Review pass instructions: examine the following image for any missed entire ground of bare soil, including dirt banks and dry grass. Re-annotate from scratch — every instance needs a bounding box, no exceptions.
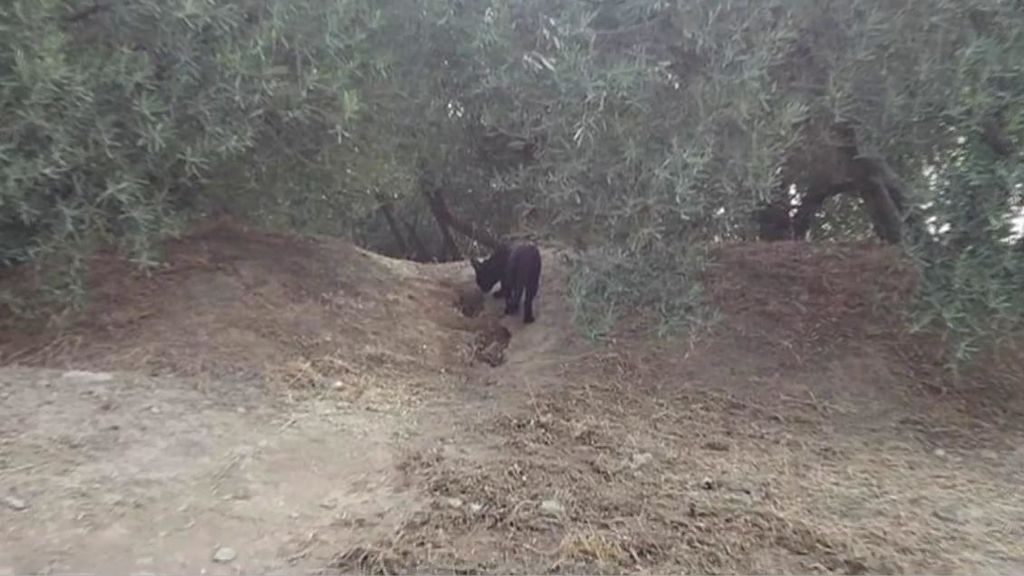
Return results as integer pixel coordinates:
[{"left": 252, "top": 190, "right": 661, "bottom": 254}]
[{"left": 0, "top": 224, "right": 1024, "bottom": 575}]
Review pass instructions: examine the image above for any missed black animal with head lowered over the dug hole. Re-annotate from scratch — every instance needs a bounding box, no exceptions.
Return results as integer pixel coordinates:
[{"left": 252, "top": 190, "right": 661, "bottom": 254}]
[{"left": 469, "top": 244, "right": 541, "bottom": 324}]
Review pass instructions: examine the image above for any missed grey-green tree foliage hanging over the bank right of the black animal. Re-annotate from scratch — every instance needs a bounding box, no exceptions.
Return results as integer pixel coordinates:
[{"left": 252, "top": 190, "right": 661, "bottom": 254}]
[{"left": 473, "top": 0, "right": 1024, "bottom": 359}]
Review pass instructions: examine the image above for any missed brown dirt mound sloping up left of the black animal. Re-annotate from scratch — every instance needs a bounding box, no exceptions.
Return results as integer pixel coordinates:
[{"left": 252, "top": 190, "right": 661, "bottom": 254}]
[{"left": 0, "top": 223, "right": 466, "bottom": 387}]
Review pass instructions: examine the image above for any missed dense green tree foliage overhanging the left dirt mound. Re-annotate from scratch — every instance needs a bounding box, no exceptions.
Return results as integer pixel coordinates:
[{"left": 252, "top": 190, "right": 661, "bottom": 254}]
[{"left": 0, "top": 0, "right": 380, "bottom": 302}]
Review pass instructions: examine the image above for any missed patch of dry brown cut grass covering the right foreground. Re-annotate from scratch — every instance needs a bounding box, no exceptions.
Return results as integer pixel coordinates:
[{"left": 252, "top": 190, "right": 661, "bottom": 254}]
[{"left": 382, "top": 344, "right": 1024, "bottom": 574}]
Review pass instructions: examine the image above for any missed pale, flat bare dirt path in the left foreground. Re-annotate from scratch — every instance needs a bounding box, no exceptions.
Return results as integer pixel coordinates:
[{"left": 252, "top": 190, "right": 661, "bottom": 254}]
[{"left": 0, "top": 369, "right": 418, "bottom": 574}]
